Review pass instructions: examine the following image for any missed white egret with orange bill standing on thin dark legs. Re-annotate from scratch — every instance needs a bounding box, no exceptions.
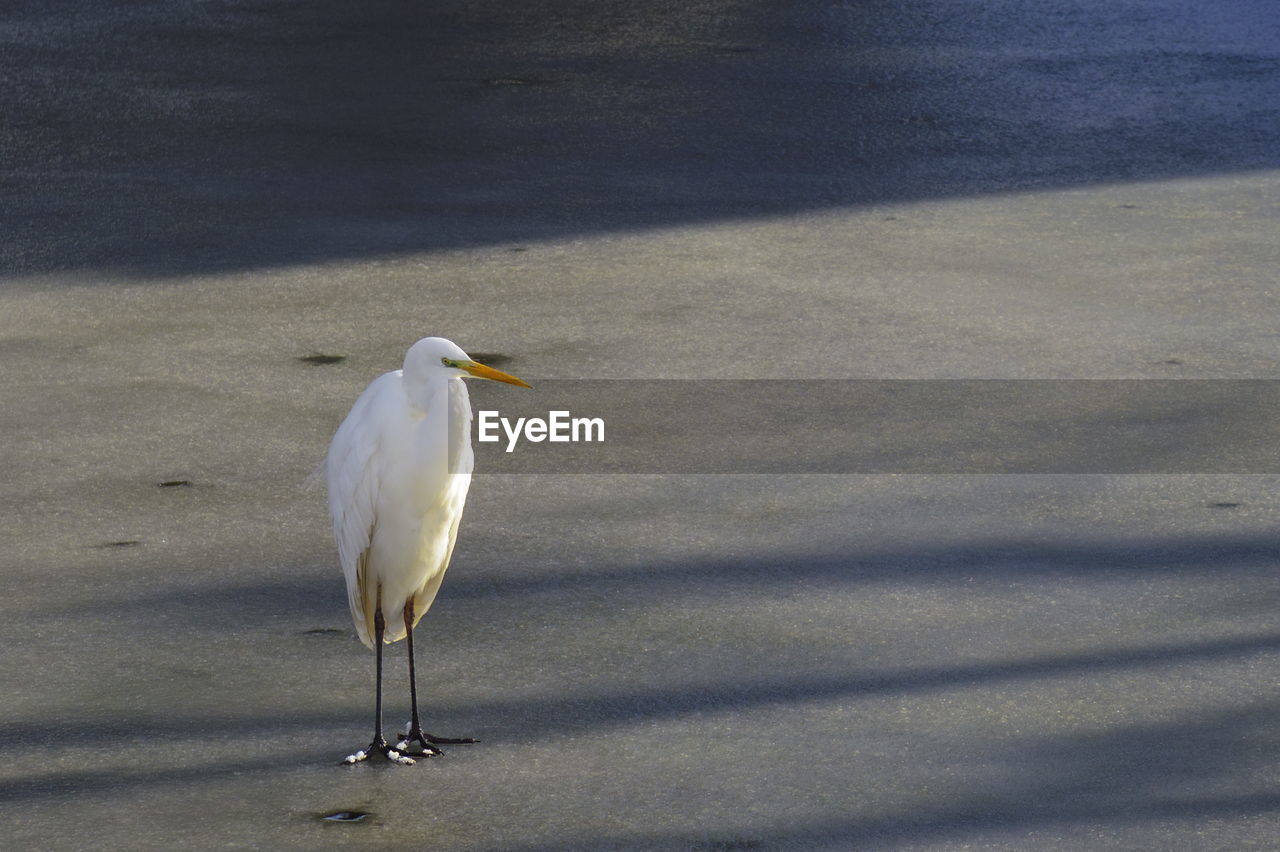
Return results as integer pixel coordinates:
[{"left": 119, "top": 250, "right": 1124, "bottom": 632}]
[{"left": 325, "top": 338, "right": 529, "bottom": 764}]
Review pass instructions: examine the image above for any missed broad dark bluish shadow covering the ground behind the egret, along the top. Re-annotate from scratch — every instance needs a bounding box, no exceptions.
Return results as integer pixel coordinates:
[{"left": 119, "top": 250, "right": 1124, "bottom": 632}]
[{"left": 0, "top": 0, "right": 1280, "bottom": 278}]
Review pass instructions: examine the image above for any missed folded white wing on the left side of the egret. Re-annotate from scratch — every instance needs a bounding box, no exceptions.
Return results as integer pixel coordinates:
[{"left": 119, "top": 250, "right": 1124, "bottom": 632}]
[{"left": 325, "top": 371, "right": 406, "bottom": 647}]
